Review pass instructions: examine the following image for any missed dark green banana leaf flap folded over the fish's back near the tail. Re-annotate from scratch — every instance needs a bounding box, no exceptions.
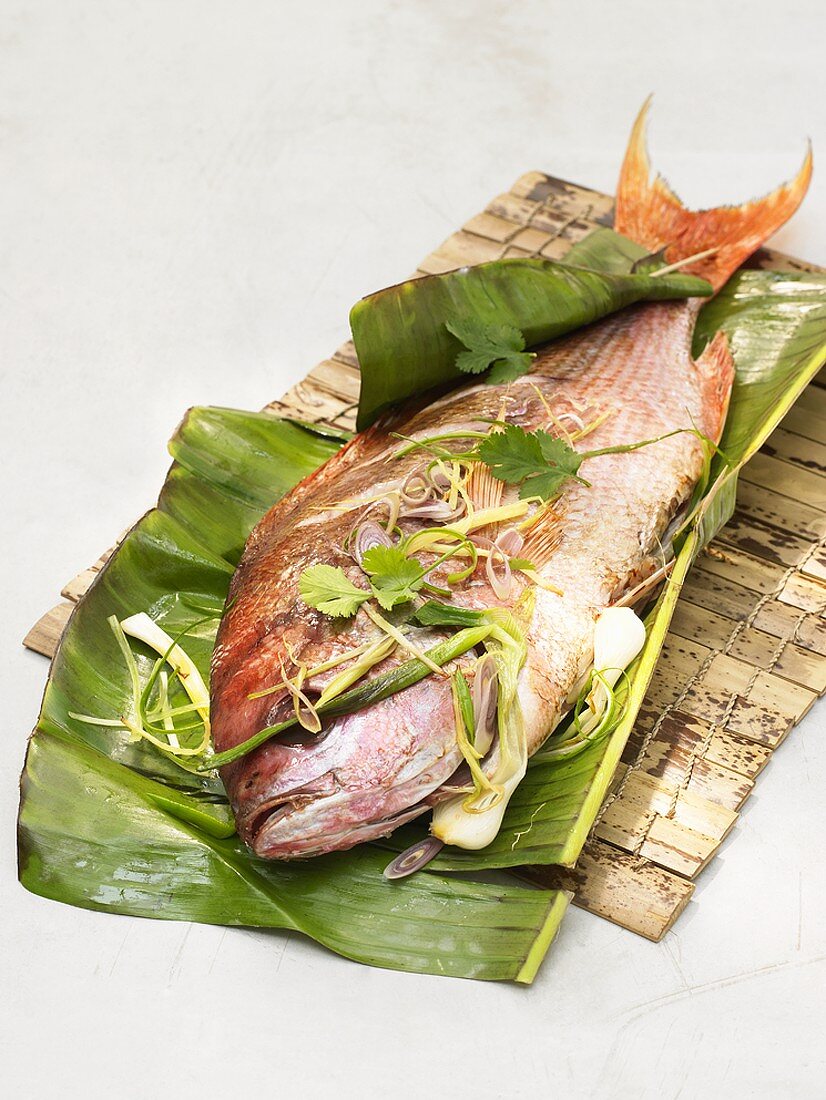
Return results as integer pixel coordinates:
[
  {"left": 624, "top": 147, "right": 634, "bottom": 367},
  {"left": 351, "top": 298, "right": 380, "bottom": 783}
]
[{"left": 350, "top": 229, "right": 712, "bottom": 430}]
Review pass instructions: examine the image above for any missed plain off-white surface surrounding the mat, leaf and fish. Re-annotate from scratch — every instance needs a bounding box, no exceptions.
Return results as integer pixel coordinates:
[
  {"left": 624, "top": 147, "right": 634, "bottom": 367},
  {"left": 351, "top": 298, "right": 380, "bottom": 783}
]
[{"left": 0, "top": 0, "right": 826, "bottom": 1100}]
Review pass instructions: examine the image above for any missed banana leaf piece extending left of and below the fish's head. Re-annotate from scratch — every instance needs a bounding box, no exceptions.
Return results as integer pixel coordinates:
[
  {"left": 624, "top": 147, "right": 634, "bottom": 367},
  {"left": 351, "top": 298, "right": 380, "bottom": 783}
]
[{"left": 19, "top": 409, "right": 569, "bottom": 982}]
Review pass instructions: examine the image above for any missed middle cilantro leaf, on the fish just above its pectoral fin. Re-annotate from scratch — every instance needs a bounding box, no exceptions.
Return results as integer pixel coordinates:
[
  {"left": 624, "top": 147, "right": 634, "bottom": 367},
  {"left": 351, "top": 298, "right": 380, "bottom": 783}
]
[{"left": 478, "top": 424, "right": 582, "bottom": 501}]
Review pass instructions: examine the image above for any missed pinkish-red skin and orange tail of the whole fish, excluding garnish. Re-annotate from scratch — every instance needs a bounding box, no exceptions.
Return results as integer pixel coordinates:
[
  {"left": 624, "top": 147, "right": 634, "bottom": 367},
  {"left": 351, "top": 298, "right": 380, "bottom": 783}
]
[{"left": 211, "top": 109, "right": 811, "bottom": 859}]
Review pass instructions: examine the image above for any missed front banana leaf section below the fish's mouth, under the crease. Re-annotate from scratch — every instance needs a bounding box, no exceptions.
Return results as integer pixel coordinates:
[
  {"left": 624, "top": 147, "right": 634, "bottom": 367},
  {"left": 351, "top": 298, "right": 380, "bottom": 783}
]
[{"left": 20, "top": 733, "right": 566, "bottom": 981}]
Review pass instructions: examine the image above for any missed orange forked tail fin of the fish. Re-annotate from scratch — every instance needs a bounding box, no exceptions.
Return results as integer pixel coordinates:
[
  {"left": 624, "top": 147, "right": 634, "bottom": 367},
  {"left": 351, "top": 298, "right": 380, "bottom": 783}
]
[{"left": 615, "top": 99, "right": 812, "bottom": 290}]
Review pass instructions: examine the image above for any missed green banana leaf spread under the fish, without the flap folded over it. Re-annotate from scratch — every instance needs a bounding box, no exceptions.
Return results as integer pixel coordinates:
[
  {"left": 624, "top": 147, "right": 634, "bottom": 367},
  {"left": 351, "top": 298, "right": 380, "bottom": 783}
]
[{"left": 20, "top": 249, "right": 826, "bottom": 981}]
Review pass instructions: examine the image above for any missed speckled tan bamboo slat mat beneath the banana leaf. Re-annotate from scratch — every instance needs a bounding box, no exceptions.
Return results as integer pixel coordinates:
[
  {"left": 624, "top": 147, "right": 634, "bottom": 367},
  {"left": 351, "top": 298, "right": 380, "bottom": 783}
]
[{"left": 24, "top": 172, "right": 826, "bottom": 939}]
